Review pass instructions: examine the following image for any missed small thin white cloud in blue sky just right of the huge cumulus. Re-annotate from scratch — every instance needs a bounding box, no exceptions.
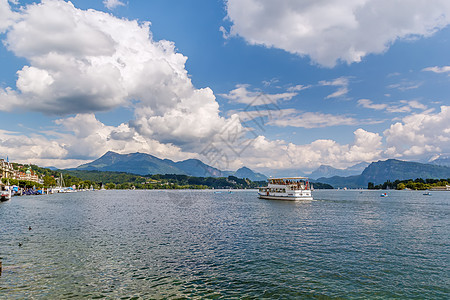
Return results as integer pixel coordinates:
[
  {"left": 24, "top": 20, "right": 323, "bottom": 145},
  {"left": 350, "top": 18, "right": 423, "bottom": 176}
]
[{"left": 220, "top": 84, "right": 297, "bottom": 106}]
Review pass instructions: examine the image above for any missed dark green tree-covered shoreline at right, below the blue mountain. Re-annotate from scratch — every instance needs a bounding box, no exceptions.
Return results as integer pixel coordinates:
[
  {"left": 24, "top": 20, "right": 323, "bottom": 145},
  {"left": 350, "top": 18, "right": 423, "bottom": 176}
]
[{"left": 367, "top": 178, "right": 450, "bottom": 190}]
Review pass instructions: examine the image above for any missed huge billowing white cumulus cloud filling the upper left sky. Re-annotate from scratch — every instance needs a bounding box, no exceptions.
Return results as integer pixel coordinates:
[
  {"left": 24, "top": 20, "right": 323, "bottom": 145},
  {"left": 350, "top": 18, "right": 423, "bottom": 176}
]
[{"left": 0, "top": 0, "right": 236, "bottom": 147}]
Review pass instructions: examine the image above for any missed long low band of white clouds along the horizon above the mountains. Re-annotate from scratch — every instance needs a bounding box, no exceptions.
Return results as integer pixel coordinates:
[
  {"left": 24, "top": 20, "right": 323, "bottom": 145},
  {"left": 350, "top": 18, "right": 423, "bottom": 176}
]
[{"left": 0, "top": 106, "right": 450, "bottom": 172}]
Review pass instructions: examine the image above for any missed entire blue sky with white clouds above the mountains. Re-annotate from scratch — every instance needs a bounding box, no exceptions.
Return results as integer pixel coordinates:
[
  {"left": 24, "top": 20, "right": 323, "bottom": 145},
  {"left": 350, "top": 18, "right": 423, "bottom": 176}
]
[{"left": 0, "top": 0, "right": 450, "bottom": 175}]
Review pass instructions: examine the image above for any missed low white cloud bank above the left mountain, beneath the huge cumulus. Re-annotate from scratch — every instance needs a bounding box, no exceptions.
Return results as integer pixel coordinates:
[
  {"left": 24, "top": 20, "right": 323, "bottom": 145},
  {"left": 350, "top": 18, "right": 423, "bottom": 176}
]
[{"left": 0, "top": 114, "right": 196, "bottom": 168}]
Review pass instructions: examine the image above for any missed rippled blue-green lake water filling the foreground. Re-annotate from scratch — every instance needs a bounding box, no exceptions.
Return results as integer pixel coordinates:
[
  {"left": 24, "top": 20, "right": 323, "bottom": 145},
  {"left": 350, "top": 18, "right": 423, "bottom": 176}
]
[{"left": 0, "top": 190, "right": 450, "bottom": 299}]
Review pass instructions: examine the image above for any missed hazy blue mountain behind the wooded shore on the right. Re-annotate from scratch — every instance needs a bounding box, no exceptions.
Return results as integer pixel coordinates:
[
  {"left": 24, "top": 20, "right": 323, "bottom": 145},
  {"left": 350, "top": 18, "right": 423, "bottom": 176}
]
[{"left": 317, "top": 159, "right": 450, "bottom": 188}]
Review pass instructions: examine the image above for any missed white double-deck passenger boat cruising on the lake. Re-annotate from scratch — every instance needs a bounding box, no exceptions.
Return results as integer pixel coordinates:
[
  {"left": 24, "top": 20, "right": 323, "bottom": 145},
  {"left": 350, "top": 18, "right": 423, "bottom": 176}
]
[{"left": 258, "top": 177, "right": 313, "bottom": 200}]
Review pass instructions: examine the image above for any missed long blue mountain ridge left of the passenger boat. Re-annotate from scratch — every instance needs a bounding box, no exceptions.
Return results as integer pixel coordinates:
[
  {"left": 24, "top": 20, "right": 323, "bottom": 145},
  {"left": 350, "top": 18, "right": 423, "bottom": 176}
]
[{"left": 73, "top": 151, "right": 267, "bottom": 181}]
